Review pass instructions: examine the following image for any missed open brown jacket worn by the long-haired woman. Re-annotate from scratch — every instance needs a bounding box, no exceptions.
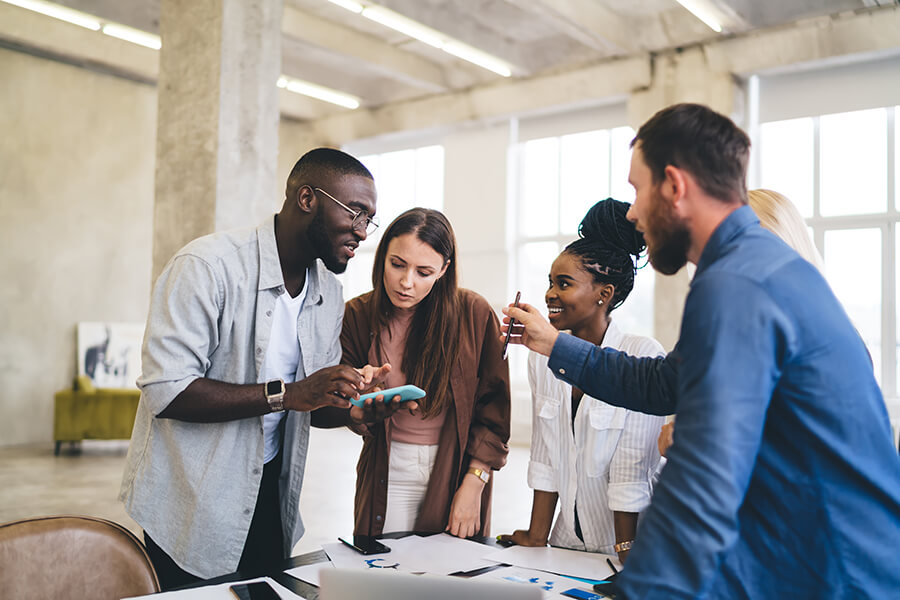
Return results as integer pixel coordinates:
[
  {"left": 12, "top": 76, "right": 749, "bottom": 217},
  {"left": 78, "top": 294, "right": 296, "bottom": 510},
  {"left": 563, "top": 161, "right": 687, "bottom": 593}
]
[{"left": 341, "top": 289, "right": 510, "bottom": 535}]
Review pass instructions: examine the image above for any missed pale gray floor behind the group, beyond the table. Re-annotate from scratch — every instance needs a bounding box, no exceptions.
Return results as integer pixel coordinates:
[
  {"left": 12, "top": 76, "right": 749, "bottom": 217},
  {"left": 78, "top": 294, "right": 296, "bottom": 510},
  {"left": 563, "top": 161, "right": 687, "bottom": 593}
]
[{"left": 0, "top": 429, "right": 531, "bottom": 554}]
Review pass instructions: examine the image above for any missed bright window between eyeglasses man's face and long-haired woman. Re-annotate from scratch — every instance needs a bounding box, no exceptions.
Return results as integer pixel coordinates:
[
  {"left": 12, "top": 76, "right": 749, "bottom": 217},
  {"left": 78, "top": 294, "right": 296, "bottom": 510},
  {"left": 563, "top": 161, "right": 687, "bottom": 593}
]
[{"left": 342, "top": 146, "right": 444, "bottom": 300}]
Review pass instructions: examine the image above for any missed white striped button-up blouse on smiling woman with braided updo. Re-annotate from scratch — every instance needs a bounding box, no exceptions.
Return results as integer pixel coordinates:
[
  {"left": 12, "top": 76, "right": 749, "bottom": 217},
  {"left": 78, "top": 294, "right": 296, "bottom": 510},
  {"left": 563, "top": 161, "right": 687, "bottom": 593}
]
[{"left": 528, "top": 322, "right": 665, "bottom": 554}]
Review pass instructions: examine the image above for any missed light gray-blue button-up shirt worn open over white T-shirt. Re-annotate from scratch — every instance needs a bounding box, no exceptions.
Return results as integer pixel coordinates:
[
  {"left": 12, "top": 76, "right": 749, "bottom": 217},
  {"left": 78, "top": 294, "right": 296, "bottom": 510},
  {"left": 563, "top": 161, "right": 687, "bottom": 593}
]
[{"left": 120, "top": 217, "right": 344, "bottom": 578}]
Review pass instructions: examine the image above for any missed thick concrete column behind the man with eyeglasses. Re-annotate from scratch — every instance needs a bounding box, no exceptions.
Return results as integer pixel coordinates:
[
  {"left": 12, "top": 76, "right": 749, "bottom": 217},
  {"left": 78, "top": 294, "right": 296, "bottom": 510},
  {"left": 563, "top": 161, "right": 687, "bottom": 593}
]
[{"left": 152, "top": 0, "right": 283, "bottom": 280}]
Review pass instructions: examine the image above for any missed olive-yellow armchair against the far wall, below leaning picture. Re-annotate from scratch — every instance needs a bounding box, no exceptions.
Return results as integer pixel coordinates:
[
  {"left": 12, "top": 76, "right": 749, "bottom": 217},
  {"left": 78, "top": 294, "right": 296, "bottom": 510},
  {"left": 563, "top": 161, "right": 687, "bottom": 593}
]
[{"left": 53, "top": 375, "right": 141, "bottom": 455}]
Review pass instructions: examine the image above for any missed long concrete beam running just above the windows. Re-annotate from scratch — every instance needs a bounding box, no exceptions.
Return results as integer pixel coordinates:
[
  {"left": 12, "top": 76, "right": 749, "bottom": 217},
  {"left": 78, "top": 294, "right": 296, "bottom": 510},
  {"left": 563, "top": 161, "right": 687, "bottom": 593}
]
[{"left": 306, "top": 7, "right": 900, "bottom": 144}]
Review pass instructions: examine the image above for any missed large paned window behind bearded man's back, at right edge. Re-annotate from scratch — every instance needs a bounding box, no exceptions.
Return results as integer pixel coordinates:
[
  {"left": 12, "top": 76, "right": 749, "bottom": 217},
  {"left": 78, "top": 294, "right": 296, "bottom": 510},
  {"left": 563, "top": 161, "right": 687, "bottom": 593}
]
[{"left": 759, "top": 106, "right": 900, "bottom": 396}]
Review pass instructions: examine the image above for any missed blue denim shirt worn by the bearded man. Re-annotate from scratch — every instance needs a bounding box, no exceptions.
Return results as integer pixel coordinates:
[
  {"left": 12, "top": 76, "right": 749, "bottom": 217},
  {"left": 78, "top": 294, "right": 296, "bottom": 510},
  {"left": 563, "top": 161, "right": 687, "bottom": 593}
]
[{"left": 548, "top": 207, "right": 900, "bottom": 599}]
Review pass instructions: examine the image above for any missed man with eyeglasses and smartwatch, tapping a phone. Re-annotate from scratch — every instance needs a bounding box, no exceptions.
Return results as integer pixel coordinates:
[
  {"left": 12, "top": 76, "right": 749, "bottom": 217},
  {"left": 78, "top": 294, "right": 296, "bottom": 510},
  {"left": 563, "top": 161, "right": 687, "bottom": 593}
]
[{"left": 120, "top": 148, "right": 384, "bottom": 589}]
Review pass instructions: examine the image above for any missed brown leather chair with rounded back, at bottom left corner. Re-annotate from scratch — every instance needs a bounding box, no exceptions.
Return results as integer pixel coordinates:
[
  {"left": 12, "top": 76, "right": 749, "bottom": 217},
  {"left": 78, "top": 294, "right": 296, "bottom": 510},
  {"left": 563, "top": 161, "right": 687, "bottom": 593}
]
[{"left": 0, "top": 516, "right": 159, "bottom": 600}]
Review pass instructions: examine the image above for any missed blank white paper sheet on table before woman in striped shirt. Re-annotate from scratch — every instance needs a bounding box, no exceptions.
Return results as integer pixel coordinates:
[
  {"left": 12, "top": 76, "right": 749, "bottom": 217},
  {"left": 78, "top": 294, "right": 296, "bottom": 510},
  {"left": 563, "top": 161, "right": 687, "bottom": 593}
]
[{"left": 482, "top": 546, "right": 620, "bottom": 579}]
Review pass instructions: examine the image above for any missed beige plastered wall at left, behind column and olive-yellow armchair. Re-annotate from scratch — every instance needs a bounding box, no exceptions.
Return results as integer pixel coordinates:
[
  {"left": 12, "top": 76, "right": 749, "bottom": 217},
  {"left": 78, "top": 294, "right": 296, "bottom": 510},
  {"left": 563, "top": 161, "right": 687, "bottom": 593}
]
[{"left": 0, "top": 49, "right": 334, "bottom": 445}]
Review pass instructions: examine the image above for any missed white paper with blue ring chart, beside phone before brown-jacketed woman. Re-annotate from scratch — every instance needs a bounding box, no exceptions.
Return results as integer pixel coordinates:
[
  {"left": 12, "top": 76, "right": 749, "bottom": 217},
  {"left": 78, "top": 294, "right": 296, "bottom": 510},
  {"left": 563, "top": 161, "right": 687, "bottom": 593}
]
[{"left": 322, "top": 533, "right": 495, "bottom": 575}]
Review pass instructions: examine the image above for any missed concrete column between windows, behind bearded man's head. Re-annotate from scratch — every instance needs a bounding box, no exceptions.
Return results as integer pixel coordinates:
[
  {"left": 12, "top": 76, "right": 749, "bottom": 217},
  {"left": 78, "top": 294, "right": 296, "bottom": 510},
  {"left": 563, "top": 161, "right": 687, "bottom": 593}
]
[{"left": 628, "top": 47, "right": 744, "bottom": 350}]
